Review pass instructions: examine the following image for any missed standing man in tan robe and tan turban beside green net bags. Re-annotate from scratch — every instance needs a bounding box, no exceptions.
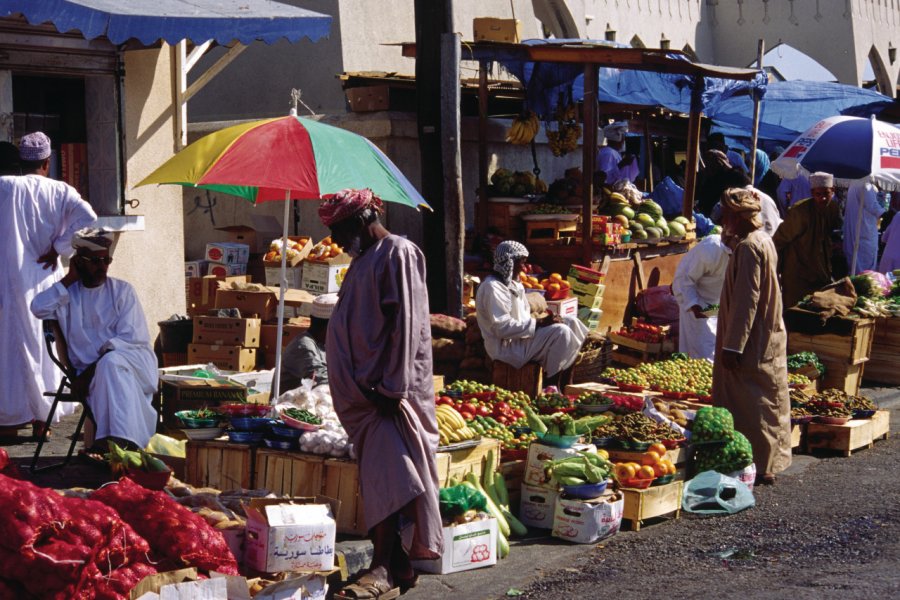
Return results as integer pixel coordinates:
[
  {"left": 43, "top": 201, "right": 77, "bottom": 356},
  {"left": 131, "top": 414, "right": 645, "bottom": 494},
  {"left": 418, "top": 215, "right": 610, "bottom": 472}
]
[{"left": 712, "top": 188, "right": 791, "bottom": 483}]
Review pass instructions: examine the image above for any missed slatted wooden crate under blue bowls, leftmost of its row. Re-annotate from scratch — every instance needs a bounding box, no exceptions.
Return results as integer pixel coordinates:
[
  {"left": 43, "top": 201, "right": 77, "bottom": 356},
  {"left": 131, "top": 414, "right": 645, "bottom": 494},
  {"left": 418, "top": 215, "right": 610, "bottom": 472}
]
[{"left": 184, "top": 441, "right": 256, "bottom": 490}]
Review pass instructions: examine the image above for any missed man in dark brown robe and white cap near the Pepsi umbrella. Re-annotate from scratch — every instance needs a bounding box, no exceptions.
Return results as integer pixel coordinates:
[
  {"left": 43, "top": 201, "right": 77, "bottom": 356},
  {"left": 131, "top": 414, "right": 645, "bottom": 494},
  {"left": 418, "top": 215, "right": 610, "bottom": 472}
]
[{"left": 772, "top": 173, "right": 842, "bottom": 308}]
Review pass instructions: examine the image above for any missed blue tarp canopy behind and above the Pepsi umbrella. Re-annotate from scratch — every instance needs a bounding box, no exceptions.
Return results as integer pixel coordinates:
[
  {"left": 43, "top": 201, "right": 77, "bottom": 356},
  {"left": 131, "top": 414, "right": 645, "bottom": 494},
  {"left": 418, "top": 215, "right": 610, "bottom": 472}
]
[{"left": 706, "top": 81, "right": 893, "bottom": 142}]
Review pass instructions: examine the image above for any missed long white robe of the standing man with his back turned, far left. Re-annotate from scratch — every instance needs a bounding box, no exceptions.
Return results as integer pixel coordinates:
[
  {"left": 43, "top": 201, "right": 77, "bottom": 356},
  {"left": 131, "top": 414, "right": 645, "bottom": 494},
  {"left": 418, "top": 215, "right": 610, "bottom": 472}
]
[{"left": 0, "top": 175, "right": 97, "bottom": 426}]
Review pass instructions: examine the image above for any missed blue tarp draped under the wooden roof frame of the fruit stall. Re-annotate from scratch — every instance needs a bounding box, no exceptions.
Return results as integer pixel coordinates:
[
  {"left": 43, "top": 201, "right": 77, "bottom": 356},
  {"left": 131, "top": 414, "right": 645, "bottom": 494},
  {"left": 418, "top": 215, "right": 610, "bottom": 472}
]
[{"left": 499, "top": 40, "right": 766, "bottom": 118}]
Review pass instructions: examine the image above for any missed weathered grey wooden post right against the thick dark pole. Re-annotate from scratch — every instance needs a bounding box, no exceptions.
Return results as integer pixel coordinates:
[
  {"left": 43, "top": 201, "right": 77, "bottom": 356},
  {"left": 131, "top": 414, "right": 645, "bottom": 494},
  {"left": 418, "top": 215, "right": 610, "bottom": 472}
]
[{"left": 441, "top": 33, "right": 465, "bottom": 317}]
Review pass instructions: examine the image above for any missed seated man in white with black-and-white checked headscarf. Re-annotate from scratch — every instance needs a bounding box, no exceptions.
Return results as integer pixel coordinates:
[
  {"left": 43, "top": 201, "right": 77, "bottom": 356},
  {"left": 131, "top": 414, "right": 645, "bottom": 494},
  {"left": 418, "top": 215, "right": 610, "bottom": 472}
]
[{"left": 475, "top": 240, "right": 588, "bottom": 389}]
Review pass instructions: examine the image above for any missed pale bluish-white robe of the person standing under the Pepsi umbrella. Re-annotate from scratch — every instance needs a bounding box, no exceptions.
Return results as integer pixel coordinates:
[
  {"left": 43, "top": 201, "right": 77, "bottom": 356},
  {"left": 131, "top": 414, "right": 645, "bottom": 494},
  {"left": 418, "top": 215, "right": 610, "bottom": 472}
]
[{"left": 844, "top": 181, "right": 887, "bottom": 275}]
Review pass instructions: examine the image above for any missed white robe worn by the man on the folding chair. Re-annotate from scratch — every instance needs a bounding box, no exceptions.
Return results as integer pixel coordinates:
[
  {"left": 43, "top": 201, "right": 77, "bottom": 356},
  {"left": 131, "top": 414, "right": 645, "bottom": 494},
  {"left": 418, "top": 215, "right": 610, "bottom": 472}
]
[{"left": 31, "top": 277, "right": 158, "bottom": 448}]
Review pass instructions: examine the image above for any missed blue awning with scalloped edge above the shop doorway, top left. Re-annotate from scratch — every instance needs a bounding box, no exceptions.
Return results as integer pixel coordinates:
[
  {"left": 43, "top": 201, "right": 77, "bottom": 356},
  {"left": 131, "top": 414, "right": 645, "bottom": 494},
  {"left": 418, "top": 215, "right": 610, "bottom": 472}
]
[{"left": 0, "top": 0, "right": 331, "bottom": 45}]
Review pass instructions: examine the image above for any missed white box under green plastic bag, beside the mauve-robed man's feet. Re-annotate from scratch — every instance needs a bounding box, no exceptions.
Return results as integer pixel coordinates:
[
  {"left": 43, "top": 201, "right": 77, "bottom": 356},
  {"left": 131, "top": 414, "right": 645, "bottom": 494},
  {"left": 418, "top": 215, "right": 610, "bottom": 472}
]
[{"left": 413, "top": 517, "right": 497, "bottom": 575}]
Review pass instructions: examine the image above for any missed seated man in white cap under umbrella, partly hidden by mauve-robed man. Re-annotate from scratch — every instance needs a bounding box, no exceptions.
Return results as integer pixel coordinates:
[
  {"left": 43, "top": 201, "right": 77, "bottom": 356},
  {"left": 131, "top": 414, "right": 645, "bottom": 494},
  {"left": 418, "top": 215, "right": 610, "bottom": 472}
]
[{"left": 281, "top": 294, "right": 337, "bottom": 391}]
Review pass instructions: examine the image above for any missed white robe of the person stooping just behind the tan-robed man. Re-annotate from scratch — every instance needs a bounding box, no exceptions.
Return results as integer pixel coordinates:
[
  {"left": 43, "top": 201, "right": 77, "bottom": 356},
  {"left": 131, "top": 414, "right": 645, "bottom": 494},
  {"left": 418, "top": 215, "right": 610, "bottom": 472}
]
[{"left": 672, "top": 235, "right": 731, "bottom": 362}]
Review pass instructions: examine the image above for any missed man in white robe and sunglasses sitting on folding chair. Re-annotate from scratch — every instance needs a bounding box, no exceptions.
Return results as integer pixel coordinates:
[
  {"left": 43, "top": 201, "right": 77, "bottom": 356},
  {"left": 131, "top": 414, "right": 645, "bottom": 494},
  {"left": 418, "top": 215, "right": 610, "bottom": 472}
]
[{"left": 31, "top": 229, "right": 157, "bottom": 458}]
